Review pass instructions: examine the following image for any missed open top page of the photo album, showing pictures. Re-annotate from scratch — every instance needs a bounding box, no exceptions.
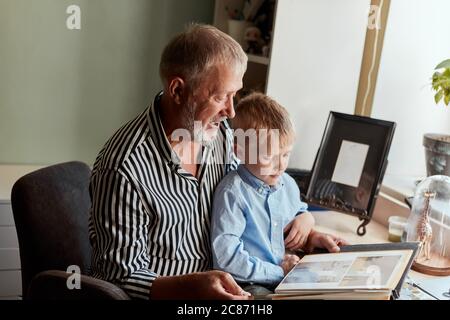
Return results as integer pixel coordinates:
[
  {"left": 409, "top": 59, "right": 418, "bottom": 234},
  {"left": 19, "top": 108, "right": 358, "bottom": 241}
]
[{"left": 275, "top": 250, "right": 413, "bottom": 293}]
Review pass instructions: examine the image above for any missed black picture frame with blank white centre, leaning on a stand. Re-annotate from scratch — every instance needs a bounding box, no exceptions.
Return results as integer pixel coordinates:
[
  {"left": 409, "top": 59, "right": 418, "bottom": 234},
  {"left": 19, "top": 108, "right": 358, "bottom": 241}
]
[{"left": 306, "top": 111, "right": 396, "bottom": 236}]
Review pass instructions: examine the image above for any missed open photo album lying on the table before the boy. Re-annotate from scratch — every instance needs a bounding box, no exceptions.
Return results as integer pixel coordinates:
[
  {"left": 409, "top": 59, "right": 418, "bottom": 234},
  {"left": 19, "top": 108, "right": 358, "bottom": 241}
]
[{"left": 272, "top": 242, "right": 418, "bottom": 300}]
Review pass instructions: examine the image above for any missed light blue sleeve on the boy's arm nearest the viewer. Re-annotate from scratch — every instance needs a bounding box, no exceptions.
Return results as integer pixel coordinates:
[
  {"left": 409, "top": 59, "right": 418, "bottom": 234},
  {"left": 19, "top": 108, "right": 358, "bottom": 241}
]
[{"left": 211, "top": 185, "right": 284, "bottom": 284}]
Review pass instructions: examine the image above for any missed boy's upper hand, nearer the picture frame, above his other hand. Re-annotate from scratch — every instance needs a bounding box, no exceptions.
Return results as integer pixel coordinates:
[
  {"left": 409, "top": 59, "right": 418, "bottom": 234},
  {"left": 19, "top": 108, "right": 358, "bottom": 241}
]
[{"left": 284, "top": 212, "right": 315, "bottom": 251}]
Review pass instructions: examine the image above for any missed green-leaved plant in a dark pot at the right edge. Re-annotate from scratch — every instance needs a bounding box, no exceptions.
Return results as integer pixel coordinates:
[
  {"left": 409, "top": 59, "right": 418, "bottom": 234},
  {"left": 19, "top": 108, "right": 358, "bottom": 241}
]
[{"left": 423, "top": 59, "right": 450, "bottom": 176}]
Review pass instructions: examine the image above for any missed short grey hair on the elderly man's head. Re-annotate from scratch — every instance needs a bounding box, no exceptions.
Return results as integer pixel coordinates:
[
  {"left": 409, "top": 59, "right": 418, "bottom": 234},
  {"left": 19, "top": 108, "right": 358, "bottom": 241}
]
[{"left": 159, "top": 24, "right": 247, "bottom": 88}]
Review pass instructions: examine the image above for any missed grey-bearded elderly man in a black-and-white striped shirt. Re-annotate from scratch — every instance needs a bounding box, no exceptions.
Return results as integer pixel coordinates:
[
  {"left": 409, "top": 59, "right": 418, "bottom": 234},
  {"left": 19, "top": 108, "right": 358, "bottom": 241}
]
[{"left": 89, "top": 25, "right": 348, "bottom": 299}]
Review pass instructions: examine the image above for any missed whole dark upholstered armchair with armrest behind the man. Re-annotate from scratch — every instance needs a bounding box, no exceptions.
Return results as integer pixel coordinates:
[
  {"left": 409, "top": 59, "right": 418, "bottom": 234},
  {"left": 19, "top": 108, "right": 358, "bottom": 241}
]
[{"left": 11, "top": 162, "right": 129, "bottom": 299}]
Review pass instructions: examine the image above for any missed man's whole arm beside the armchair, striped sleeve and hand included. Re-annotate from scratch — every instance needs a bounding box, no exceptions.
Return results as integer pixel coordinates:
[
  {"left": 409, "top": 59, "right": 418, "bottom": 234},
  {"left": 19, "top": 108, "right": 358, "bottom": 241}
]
[{"left": 91, "top": 170, "right": 249, "bottom": 299}]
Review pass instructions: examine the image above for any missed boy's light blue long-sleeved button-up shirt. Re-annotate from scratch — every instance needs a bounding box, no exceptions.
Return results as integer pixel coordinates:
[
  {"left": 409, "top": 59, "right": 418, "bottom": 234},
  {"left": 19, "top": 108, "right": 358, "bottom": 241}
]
[{"left": 211, "top": 165, "right": 308, "bottom": 284}]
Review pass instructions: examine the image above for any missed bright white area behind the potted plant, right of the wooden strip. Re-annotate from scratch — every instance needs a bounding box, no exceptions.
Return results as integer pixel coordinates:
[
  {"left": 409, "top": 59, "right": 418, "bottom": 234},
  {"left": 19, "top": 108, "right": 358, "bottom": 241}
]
[{"left": 372, "top": 0, "right": 450, "bottom": 176}]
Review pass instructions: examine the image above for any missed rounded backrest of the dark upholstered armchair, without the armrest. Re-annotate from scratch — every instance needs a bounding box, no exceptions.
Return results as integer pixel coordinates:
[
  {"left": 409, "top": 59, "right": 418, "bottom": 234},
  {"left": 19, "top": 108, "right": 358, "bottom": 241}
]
[{"left": 11, "top": 162, "right": 91, "bottom": 298}]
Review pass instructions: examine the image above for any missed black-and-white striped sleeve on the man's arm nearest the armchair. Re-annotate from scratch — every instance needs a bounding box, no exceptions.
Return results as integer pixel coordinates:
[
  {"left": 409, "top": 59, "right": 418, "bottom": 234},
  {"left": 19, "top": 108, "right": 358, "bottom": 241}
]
[{"left": 90, "top": 169, "right": 157, "bottom": 299}]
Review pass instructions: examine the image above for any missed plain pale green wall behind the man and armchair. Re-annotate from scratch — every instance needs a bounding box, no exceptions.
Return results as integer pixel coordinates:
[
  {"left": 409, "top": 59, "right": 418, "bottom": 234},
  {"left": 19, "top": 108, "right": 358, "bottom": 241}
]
[{"left": 0, "top": 0, "right": 214, "bottom": 164}]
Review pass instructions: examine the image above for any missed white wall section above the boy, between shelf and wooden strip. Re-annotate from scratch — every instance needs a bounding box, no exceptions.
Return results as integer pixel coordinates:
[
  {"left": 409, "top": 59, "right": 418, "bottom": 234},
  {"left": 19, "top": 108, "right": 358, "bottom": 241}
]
[{"left": 267, "top": 0, "right": 370, "bottom": 169}]
